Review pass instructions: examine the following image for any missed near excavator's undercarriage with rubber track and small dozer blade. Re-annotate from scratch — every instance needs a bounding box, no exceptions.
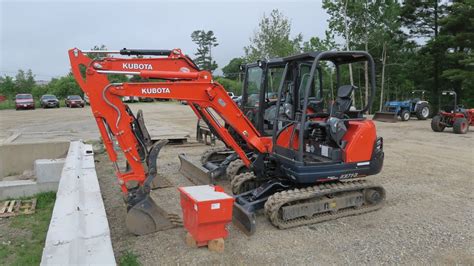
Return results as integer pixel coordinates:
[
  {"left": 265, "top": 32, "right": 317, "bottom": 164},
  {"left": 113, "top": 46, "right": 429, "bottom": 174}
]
[{"left": 234, "top": 174, "right": 385, "bottom": 235}]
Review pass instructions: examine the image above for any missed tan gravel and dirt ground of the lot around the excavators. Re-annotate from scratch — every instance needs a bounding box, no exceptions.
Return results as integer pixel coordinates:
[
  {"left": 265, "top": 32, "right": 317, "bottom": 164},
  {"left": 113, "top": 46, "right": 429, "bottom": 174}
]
[{"left": 0, "top": 103, "right": 474, "bottom": 265}]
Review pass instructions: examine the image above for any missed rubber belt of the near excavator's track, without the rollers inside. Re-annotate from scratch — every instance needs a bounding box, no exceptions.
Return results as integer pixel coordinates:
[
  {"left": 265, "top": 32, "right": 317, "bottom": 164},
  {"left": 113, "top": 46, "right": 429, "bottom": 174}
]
[{"left": 265, "top": 180, "right": 385, "bottom": 229}]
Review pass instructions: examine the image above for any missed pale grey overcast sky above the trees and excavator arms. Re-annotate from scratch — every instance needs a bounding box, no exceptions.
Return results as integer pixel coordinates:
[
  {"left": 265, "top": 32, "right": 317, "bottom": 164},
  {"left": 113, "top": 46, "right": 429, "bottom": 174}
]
[{"left": 0, "top": 0, "right": 328, "bottom": 80}]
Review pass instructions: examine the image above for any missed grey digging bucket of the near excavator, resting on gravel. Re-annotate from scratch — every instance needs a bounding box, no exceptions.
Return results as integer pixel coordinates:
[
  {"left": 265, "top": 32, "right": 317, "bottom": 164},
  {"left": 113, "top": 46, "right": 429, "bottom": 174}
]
[{"left": 125, "top": 195, "right": 182, "bottom": 235}]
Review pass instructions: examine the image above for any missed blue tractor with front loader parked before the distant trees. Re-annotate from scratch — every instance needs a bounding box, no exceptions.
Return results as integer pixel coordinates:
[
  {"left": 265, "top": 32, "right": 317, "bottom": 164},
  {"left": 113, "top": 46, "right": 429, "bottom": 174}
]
[{"left": 372, "top": 90, "right": 431, "bottom": 122}]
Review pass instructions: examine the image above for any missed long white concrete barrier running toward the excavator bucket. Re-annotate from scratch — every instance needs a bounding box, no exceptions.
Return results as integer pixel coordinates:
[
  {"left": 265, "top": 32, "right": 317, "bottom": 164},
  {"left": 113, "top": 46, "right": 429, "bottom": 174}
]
[{"left": 41, "top": 141, "right": 116, "bottom": 265}]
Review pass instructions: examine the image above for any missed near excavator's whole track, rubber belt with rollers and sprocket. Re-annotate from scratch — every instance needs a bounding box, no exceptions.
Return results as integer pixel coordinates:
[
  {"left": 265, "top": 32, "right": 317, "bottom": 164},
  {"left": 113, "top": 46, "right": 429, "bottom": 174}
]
[{"left": 265, "top": 180, "right": 385, "bottom": 229}]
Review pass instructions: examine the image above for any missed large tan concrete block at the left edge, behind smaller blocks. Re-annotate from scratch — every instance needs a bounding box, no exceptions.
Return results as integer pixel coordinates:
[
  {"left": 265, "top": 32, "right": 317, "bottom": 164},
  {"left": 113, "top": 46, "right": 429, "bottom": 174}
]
[{"left": 0, "top": 141, "right": 69, "bottom": 177}]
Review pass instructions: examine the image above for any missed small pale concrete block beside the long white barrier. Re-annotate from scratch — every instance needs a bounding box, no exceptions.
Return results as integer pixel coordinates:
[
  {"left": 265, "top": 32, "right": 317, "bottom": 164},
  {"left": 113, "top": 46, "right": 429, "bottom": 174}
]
[{"left": 34, "top": 159, "right": 66, "bottom": 183}]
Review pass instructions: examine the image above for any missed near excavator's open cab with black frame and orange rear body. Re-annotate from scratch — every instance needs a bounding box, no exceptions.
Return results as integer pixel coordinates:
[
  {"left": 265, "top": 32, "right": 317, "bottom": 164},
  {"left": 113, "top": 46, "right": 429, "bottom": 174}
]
[{"left": 266, "top": 51, "right": 381, "bottom": 183}]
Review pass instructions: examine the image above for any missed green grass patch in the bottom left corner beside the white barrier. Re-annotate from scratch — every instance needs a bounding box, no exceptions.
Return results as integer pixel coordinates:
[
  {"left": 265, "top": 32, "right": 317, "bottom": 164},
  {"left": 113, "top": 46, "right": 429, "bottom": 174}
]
[{"left": 0, "top": 192, "right": 56, "bottom": 265}]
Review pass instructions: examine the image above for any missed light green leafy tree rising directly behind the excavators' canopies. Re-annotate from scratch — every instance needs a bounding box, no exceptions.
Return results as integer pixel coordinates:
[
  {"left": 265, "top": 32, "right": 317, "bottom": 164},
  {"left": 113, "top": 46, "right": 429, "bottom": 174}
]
[{"left": 244, "top": 9, "right": 303, "bottom": 62}]
